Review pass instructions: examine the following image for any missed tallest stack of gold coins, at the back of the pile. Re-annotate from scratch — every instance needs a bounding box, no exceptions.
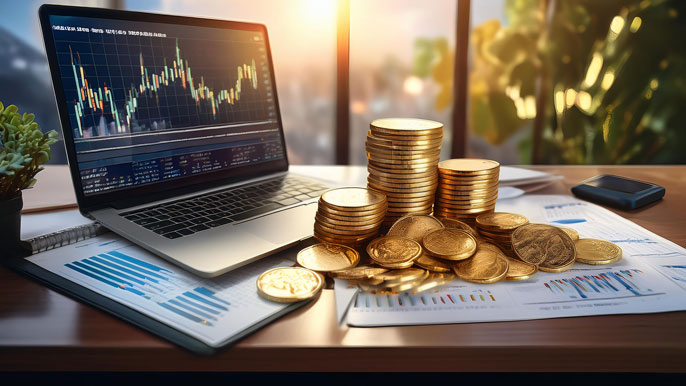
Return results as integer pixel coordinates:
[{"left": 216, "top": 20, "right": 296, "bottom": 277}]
[{"left": 366, "top": 118, "right": 443, "bottom": 229}]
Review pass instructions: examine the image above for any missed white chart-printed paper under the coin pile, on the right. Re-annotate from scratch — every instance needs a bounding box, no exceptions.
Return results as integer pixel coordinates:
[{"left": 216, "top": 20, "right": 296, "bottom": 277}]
[{"left": 344, "top": 195, "right": 686, "bottom": 326}]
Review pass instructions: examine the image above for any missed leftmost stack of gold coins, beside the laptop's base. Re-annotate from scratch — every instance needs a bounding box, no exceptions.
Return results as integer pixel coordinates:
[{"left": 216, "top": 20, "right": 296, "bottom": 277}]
[{"left": 314, "top": 187, "right": 388, "bottom": 248}]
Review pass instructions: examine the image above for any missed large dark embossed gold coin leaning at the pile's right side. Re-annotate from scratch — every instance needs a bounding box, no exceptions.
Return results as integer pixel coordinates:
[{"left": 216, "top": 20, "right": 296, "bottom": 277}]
[{"left": 512, "top": 224, "right": 576, "bottom": 269}]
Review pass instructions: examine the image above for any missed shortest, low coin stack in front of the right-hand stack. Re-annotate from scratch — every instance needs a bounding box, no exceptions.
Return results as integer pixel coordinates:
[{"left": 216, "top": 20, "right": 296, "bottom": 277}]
[{"left": 476, "top": 212, "right": 529, "bottom": 256}]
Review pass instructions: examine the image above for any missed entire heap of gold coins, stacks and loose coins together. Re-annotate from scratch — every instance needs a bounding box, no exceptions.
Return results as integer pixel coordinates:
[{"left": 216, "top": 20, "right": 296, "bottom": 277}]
[{"left": 258, "top": 118, "right": 622, "bottom": 302}]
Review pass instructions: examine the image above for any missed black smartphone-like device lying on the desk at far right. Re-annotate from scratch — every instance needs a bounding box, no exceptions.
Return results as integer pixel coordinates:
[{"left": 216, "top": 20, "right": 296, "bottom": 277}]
[{"left": 572, "top": 174, "right": 665, "bottom": 209}]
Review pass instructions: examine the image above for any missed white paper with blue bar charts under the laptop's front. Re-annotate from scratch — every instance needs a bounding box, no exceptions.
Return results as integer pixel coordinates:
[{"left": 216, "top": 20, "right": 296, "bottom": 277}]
[{"left": 27, "top": 233, "right": 293, "bottom": 347}]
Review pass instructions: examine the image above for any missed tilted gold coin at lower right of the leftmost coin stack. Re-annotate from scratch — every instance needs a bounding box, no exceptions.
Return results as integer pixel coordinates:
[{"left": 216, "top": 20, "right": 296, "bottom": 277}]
[{"left": 367, "top": 236, "right": 422, "bottom": 268}]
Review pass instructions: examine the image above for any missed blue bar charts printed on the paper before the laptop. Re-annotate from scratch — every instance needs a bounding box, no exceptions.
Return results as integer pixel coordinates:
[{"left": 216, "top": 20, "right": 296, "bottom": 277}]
[{"left": 64, "top": 251, "right": 232, "bottom": 326}]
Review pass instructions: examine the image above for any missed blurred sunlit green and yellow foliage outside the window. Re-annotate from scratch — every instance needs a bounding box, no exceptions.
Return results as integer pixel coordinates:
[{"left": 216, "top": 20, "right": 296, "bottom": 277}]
[{"left": 414, "top": 0, "right": 686, "bottom": 164}]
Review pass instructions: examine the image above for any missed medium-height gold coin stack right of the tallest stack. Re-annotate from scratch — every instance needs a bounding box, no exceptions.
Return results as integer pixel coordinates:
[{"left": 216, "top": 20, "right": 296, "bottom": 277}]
[{"left": 434, "top": 158, "right": 500, "bottom": 226}]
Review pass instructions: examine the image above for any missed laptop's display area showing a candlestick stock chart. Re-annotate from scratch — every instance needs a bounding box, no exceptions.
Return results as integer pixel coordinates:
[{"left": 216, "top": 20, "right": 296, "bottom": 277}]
[{"left": 50, "top": 15, "right": 285, "bottom": 195}]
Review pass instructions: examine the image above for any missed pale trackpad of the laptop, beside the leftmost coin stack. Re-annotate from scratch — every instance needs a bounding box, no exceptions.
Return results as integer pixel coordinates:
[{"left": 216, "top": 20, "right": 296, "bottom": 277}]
[{"left": 241, "top": 202, "right": 317, "bottom": 245}]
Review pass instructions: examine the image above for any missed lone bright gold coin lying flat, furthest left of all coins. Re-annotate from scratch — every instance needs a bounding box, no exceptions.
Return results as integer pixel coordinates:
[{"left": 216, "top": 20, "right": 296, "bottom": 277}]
[{"left": 257, "top": 267, "right": 324, "bottom": 303}]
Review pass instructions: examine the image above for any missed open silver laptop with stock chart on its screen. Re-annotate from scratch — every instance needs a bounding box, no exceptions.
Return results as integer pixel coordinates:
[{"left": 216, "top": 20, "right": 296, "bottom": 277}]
[{"left": 39, "top": 5, "right": 327, "bottom": 277}]
